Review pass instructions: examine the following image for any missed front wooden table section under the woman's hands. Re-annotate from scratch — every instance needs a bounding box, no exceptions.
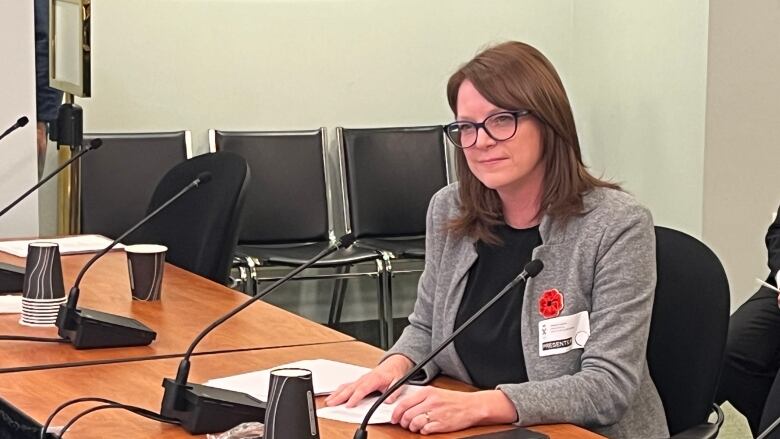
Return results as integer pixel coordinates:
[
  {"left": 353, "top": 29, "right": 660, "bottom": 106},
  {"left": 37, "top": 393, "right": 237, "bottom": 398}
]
[{"left": 0, "top": 342, "right": 601, "bottom": 439}]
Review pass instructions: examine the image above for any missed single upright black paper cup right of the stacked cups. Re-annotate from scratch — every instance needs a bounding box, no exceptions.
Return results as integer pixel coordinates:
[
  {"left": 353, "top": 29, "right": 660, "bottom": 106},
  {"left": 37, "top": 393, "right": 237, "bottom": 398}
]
[{"left": 125, "top": 244, "right": 168, "bottom": 301}]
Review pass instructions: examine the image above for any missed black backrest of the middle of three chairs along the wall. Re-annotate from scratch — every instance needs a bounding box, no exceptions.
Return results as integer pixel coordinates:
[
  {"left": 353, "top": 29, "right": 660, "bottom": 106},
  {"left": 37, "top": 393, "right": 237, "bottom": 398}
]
[{"left": 209, "top": 128, "right": 330, "bottom": 244}]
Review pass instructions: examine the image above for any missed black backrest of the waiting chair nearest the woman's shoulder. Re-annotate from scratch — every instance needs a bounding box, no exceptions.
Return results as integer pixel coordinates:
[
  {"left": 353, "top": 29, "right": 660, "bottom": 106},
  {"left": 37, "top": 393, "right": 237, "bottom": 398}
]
[{"left": 336, "top": 125, "right": 447, "bottom": 238}]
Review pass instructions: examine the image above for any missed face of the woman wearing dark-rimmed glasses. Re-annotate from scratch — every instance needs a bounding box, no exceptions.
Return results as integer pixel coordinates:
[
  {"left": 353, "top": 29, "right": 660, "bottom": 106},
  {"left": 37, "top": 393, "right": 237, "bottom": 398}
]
[{"left": 457, "top": 80, "right": 544, "bottom": 198}]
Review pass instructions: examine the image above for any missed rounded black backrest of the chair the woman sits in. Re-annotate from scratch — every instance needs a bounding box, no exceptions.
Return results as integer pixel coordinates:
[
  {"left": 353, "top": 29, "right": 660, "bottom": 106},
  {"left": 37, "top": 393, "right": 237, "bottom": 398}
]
[{"left": 647, "top": 226, "right": 729, "bottom": 435}]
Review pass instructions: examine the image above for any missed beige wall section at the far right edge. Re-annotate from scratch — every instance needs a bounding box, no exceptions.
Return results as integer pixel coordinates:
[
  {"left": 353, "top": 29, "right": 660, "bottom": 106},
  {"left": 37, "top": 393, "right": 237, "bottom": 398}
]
[{"left": 704, "top": 0, "right": 780, "bottom": 309}]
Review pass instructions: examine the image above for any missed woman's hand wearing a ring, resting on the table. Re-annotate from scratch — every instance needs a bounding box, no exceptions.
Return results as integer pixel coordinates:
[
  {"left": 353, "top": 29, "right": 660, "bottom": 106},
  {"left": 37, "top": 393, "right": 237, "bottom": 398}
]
[{"left": 391, "top": 387, "right": 517, "bottom": 434}]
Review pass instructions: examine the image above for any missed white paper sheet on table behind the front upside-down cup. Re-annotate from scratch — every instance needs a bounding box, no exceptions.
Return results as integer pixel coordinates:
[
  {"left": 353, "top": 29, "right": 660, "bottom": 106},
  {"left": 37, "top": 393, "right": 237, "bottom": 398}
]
[{"left": 205, "top": 359, "right": 371, "bottom": 401}]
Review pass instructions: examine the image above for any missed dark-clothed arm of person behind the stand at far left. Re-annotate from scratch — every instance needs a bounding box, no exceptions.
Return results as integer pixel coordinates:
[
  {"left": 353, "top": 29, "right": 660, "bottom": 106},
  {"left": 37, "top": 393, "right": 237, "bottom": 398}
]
[{"left": 35, "top": 0, "right": 62, "bottom": 175}]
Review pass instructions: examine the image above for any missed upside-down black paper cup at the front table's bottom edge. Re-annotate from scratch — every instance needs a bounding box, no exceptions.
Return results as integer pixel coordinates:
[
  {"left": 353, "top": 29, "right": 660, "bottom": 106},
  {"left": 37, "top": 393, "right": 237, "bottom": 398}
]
[{"left": 263, "top": 368, "right": 320, "bottom": 439}]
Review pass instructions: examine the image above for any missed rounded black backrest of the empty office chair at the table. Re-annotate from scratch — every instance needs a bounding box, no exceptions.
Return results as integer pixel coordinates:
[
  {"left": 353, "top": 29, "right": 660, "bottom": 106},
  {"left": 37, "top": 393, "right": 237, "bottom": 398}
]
[{"left": 125, "top": 152, "right": 250, "bottom": 283}]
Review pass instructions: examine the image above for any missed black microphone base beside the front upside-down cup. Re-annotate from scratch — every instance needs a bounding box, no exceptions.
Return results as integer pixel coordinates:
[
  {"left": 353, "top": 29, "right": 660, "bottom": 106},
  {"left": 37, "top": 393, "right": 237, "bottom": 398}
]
[{"left": 160, "top": 378, "right": 266, "bottom": 434}]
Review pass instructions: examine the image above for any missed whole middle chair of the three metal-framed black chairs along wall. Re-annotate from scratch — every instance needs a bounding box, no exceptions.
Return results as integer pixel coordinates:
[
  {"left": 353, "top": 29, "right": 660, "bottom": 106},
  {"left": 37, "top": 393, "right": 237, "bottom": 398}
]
[{"left": 209, "top": 128, "right": 384, "bottom": 334}]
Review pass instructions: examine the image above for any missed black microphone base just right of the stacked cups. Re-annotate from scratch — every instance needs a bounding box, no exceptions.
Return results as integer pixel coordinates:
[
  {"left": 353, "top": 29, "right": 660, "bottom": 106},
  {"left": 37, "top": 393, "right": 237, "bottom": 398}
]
[{"left": 56, "top": 305, "right": 157, "bottom": 349}]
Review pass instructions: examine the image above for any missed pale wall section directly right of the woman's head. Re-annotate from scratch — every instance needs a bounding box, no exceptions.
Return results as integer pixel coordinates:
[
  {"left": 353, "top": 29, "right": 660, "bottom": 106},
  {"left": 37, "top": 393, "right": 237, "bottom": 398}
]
[{"left": 567, "top": 0, "right": 708, "bottom": 237}]
